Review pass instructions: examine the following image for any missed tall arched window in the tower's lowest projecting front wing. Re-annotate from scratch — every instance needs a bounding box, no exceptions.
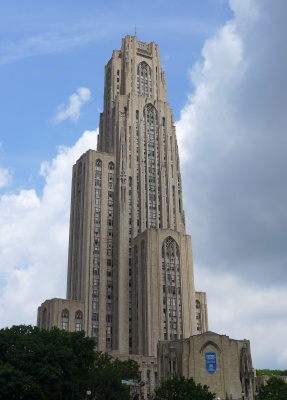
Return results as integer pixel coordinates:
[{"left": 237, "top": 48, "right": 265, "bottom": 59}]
[{"left": 162, "top": 236, "right": 182, "bottom": 340}]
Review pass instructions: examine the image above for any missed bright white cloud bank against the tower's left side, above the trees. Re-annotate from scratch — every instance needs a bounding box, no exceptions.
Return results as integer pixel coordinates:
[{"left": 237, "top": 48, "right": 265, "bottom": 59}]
[{"left": 0, "top": 131, "right": 97, "bottom": 326}]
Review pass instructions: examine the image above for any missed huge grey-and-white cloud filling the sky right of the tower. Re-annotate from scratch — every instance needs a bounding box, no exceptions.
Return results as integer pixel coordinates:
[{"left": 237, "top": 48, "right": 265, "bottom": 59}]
[{"left": 176, "top": 0, "right": 287, "bottom": 369}]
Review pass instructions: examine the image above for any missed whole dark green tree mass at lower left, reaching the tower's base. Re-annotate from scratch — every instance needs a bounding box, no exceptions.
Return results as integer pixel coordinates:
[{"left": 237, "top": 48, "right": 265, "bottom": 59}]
[{"left": 0, "top": 325, "right": 140, "bottom": 400}]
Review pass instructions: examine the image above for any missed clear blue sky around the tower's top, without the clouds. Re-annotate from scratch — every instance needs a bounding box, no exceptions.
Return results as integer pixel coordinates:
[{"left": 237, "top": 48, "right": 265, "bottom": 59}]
[{"left": 0, "top": 1, "right": 234, "bottom": 189}]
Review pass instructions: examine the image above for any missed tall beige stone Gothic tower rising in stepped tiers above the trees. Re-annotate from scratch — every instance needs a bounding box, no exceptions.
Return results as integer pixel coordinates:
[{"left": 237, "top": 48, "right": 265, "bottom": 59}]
[{"left": 38, "top": 36, "right": 207, "bottom": 357}]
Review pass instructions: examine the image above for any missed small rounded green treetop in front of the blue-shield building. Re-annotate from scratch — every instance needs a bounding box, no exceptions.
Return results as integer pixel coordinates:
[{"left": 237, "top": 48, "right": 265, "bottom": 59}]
[{"left": 154, "top": 376, "right": 215, "bottom": 400}]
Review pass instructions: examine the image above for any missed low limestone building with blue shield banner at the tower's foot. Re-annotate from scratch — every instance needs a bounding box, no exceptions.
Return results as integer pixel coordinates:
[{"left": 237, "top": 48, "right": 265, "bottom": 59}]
[{"left": 158, "top": 332, "right": 255, "bottom": 400}]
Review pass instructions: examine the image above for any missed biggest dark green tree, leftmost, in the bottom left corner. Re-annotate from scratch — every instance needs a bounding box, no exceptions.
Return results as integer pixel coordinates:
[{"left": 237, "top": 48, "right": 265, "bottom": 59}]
[{"left": 0, "top": 325, "right": 95, "bottom": 400}]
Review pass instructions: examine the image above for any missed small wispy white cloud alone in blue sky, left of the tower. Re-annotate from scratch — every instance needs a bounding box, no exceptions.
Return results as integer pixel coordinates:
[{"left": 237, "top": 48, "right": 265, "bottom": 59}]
[{"left": 54, "top": 87, "right": 91, "bottom": 122}]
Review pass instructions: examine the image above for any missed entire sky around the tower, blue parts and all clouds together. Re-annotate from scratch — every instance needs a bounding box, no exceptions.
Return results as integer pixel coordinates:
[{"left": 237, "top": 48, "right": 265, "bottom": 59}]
[{"left": 0, "top": 0, "right": 287, "bottom": 369}]
